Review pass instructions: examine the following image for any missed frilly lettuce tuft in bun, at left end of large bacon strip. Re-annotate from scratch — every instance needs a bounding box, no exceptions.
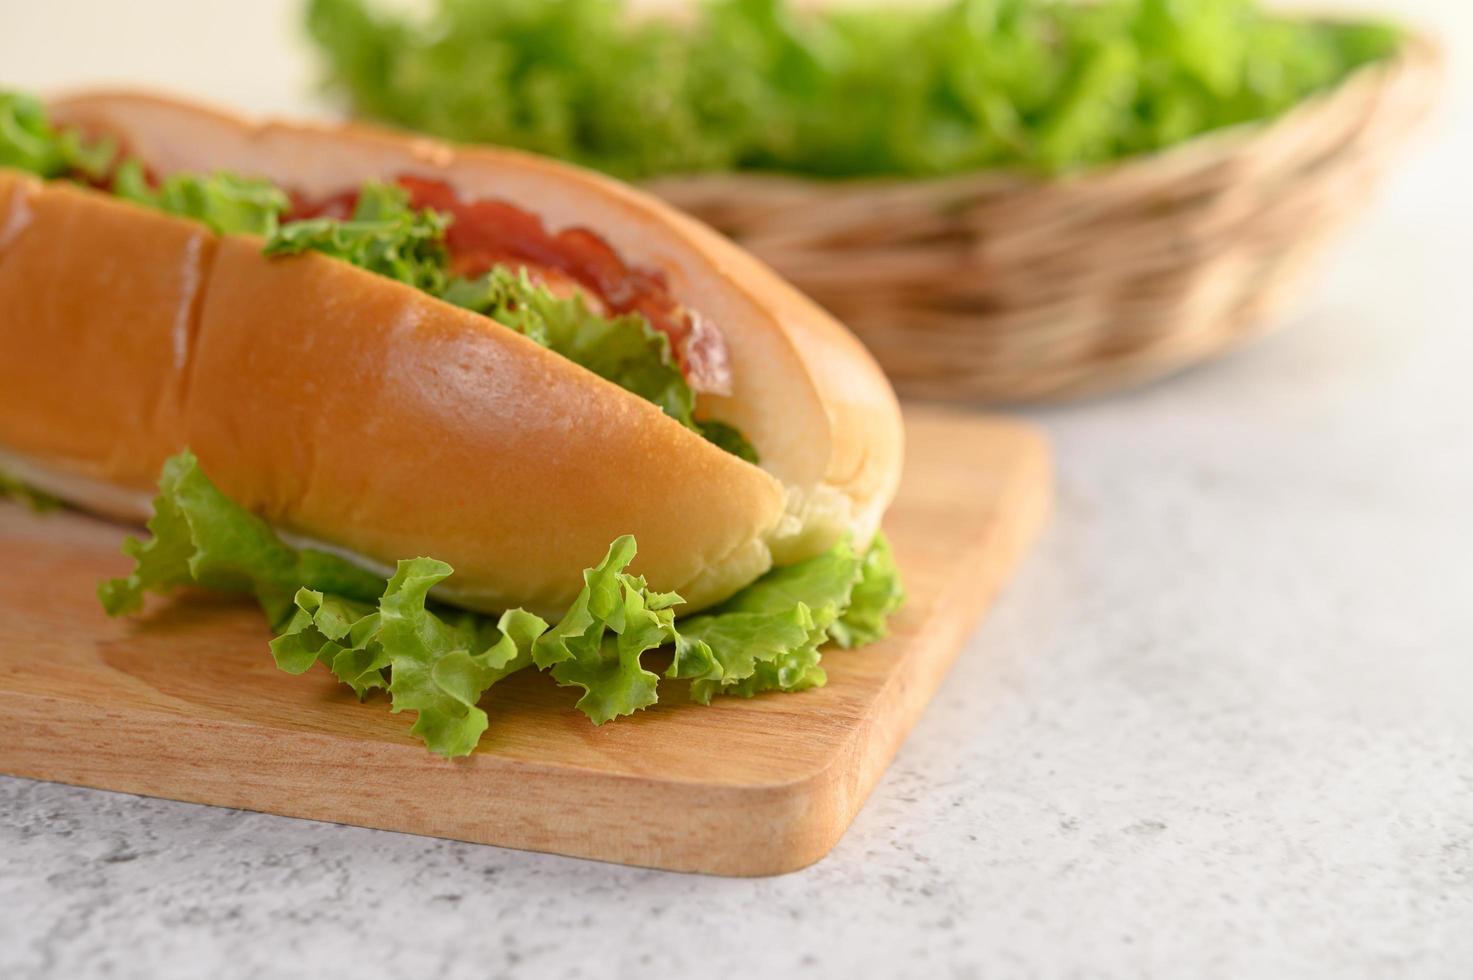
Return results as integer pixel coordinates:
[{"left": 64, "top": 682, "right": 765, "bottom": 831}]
[{"left": 265, "top": 181, "right": 449, "bottom": 295}]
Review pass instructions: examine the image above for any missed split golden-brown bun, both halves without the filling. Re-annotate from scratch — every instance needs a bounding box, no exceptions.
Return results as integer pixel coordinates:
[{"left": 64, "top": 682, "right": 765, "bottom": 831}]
[{"left": 0, "top": 94, "right": 900, "bottom": 612}]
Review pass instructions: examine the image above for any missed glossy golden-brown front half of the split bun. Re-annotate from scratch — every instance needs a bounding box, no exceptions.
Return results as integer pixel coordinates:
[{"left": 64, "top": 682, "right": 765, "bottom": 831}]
[{"left": 0, "top": 175, "right": 782, "bottom": 613}]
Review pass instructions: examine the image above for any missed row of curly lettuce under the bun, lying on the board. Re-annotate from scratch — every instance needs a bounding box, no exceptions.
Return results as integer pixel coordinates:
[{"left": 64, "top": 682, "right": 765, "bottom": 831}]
[{"left": 99, "top": 451, "right": 900, "bottom": 756}]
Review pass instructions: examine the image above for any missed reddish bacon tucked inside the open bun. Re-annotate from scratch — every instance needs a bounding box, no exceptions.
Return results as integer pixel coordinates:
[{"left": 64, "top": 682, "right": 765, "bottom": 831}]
[{"left": 292, "top": 175, "right": 731, "bottom": 395}]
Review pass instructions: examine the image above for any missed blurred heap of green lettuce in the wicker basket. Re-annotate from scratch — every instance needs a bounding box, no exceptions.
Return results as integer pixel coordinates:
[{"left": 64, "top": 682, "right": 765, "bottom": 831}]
[{"left": 308, "top": 0, "right": 1399, "bottom": 177}]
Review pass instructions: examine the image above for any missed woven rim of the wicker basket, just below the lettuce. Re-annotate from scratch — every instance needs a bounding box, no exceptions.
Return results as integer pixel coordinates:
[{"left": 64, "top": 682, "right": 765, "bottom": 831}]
[{"left": 639, "top": 29, "right": 1446, "bottom": 196}]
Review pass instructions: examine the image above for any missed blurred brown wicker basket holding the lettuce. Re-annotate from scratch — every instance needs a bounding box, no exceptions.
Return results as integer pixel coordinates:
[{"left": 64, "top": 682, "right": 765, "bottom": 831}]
[{"left": 648, "top": 38, "right": 1441, "bottom": 401}]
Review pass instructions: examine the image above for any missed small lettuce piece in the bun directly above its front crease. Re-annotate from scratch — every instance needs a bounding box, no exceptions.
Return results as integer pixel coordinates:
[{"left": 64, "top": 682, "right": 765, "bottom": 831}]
[{"left": 112, "top": 158, "right": 292, "bottom": 236}]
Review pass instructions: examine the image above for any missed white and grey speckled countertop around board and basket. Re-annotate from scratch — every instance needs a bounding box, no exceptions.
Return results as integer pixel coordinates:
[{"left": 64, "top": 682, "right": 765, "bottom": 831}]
[{"left": 0, "top": 0, "right": 1473, "bottom": 980}]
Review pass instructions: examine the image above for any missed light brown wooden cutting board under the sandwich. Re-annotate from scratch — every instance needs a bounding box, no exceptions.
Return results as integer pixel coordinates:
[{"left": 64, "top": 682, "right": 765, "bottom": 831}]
[{"left": 0, "top": 410, "right": 1050, "bottom": 875}]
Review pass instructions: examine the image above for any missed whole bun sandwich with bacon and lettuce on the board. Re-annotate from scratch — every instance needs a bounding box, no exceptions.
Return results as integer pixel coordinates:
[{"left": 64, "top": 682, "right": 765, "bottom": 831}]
[{"left": 0, "top": 93, "right": 901, "bottom": 756}]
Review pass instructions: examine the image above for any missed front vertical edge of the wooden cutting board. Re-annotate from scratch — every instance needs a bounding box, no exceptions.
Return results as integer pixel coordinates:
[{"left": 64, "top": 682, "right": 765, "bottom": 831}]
[{"left": 0, "top": 683, "right": 883, "bottom": 877}]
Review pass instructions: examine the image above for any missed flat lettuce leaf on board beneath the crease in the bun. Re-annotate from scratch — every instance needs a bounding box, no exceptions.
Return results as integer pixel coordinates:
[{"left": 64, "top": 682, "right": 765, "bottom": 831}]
[{"left": 97, "top": 451, "right": 382, "bottom": 625}]
